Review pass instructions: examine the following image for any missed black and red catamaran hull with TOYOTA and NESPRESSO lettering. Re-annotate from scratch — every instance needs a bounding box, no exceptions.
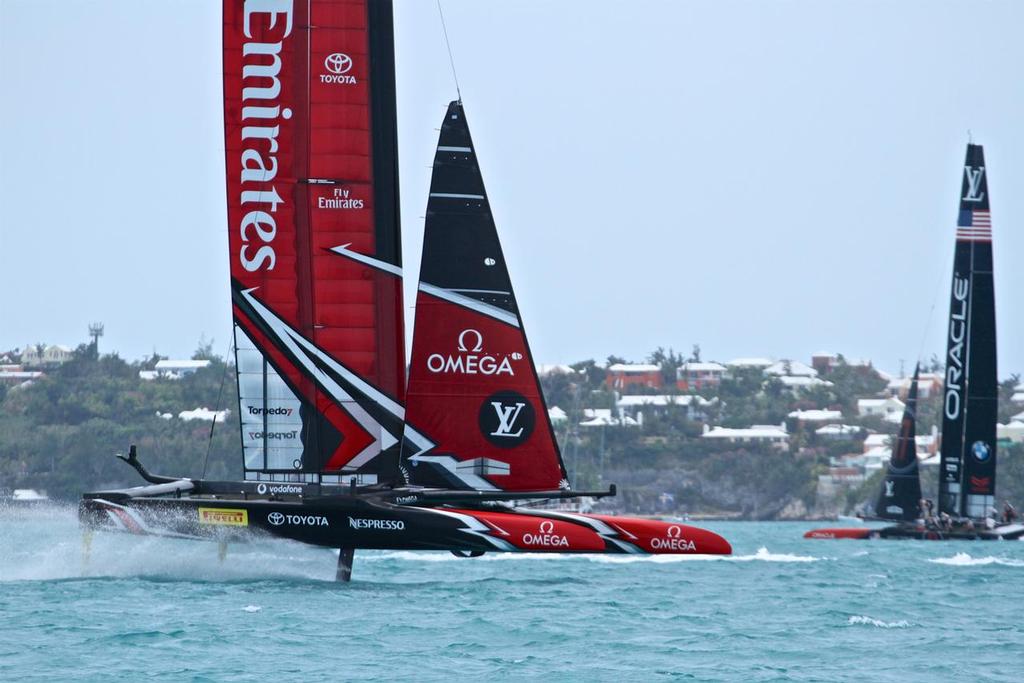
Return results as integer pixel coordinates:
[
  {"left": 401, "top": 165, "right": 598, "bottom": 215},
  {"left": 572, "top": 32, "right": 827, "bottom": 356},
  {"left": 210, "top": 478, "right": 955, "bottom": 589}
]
[{"left": 79, "top": 495, "right": 732, "bottom": 555}]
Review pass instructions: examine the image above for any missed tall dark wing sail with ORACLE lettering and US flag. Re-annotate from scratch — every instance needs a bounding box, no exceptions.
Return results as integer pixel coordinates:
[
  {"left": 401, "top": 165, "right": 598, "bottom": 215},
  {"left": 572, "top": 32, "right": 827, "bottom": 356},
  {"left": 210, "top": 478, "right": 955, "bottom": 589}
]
[{"left": 939, "top": 144, "right": 998, "bottom": 517}]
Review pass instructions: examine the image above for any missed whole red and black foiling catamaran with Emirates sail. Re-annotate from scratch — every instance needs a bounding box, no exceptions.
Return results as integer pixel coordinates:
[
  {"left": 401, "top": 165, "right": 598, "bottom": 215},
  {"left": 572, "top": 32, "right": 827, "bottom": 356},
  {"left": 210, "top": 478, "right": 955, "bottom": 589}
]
[{"left": 80, "top": 0, "right": 731, "bottom": 581}]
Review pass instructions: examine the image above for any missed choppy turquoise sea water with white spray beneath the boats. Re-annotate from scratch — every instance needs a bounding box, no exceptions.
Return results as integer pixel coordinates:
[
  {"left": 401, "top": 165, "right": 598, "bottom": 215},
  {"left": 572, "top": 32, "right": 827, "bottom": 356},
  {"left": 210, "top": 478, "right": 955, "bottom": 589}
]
[{"left": 0, "top": 508, "right": 1024, "bottom": 682}]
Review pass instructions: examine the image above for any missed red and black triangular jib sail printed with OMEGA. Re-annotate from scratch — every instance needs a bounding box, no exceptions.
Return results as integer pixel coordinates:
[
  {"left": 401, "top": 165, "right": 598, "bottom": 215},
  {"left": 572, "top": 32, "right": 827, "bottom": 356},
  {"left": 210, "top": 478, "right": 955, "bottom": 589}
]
[{"left": 402, "top": 101, "right": 568, "bottom": 492}]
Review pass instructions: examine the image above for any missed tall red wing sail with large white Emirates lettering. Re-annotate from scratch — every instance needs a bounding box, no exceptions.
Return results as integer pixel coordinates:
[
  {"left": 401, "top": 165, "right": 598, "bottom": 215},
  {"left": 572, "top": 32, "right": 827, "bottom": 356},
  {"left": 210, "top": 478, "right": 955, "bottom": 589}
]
[{"left": 223, "top": 0, "right": 404, "bottom": 482}]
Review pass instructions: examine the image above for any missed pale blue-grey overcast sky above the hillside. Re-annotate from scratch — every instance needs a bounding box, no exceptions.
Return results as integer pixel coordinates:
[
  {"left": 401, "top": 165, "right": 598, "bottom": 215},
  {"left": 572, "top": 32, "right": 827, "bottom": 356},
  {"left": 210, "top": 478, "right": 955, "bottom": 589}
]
[{"left": 0, "top": 0, "right": 1024, "bottom": 377}]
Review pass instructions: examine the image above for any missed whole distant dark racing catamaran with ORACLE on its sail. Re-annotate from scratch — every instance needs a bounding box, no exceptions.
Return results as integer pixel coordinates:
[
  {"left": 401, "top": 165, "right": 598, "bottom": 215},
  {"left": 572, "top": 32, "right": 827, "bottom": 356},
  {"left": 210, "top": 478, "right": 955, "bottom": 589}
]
[{"left": 804, "top": 144, "right": 1024, "bottom": 540}]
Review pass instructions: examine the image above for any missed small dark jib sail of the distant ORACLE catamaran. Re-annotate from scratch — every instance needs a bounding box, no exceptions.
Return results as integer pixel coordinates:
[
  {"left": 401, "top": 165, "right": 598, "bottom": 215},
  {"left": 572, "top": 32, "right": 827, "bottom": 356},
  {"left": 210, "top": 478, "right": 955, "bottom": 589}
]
[{"left": 874, "top": 368, "right": 921, "bottom": 519}]
